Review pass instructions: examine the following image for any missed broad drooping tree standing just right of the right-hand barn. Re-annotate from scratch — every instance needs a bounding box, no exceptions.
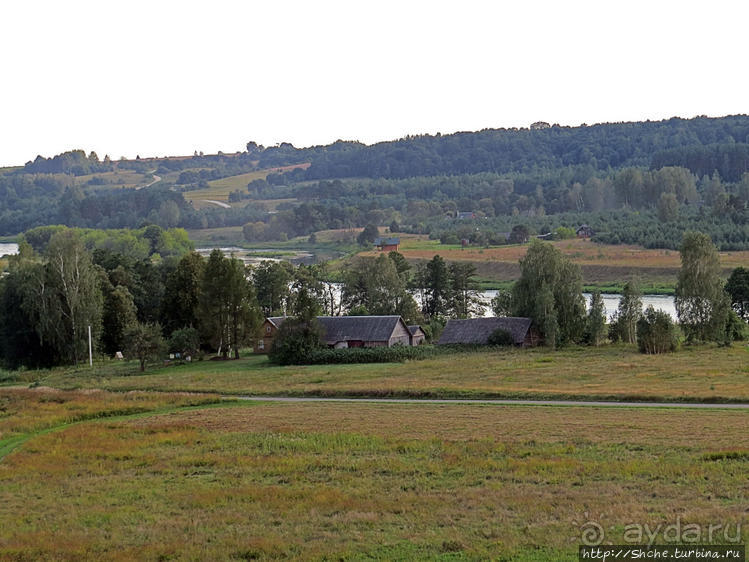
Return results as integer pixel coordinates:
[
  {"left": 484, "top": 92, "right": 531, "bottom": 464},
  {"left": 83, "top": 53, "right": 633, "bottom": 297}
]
[{"left": 513, "top": 239, "right": 585, "bottom": 347}]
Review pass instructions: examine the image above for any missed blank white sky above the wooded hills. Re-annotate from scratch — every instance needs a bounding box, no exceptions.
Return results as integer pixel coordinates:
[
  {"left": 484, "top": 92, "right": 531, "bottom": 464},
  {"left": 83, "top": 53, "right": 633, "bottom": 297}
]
[{"left": 0, "top": 0, "right": 749, "bottom": 166}]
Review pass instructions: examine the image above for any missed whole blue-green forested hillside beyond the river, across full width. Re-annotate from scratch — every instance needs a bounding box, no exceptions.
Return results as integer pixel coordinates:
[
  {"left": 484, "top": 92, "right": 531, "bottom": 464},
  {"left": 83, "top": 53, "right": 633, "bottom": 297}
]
[{"left": 0, "top": 115, "right": 749, "bottom": 250}]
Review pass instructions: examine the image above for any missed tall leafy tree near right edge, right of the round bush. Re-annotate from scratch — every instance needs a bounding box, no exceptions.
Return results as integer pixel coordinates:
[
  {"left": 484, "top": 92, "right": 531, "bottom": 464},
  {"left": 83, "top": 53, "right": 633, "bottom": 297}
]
[{"left": 675, "top": 232, "right": 730, "bottom": 341}]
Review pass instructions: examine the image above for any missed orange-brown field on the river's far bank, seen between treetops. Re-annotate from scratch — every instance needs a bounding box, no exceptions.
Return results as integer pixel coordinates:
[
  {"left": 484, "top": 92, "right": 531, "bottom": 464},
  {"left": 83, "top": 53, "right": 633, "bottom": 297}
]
[{"left": 361, "top": 235, "right": 749, "bottom": 284}]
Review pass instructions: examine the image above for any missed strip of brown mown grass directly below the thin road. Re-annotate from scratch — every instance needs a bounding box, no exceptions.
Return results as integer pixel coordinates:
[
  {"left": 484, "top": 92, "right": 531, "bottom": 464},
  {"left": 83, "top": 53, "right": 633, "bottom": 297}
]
[{"left": 139, "top": 402, "right": 749, "bottom": 451}]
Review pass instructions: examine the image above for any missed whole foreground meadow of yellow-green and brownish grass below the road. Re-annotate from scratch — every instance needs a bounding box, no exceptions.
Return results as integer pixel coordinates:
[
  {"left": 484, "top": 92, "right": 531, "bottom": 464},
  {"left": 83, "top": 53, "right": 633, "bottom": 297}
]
[{"left": 0, "top": 390, "right": 749, "bottom": 562}]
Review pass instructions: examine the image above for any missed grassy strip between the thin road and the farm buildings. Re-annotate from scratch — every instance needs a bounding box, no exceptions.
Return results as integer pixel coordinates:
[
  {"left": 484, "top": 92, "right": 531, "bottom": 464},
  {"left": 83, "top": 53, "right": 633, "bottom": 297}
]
[{"left": 38, "top": 345, "right": 749, "bottom": 401}]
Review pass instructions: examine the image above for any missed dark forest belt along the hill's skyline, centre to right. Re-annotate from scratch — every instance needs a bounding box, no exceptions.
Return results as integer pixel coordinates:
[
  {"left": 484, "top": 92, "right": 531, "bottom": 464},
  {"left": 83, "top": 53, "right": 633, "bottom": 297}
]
[{"left": 298, "top": 115, "right": 749, "bottom": 179}]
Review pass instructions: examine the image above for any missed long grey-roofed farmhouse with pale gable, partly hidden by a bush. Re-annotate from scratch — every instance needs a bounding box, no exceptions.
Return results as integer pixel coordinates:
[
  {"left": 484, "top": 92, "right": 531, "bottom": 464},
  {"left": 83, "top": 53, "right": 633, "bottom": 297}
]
[{"left": 255, "top": 316, "right": 412, "bottom": 353}]
